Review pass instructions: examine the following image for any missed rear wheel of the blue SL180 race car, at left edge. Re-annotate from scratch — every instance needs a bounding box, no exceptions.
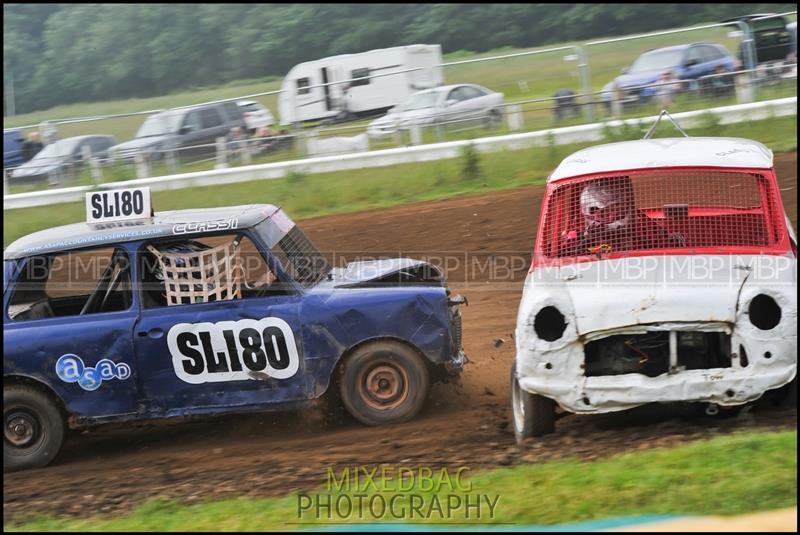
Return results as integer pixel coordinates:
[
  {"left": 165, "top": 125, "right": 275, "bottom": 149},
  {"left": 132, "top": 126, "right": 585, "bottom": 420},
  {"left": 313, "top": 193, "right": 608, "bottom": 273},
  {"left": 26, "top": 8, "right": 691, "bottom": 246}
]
[{"left": 3, "top": 386, "right": 64, "bottom": 471}]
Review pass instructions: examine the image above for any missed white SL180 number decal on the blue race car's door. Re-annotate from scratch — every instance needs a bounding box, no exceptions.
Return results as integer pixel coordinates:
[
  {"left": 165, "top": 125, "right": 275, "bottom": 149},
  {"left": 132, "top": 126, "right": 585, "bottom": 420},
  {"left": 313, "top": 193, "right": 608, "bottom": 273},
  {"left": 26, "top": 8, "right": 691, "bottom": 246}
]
[{"left": 167, "top": 318, "right": 300, "bottom": 384}]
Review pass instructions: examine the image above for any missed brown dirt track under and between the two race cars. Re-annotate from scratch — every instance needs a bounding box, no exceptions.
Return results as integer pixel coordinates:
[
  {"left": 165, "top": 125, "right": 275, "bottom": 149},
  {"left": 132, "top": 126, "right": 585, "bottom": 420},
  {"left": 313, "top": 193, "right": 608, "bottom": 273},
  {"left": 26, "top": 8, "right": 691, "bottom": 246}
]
[{"left": 3, "top": 154, "right": 797, "bottom": 522}]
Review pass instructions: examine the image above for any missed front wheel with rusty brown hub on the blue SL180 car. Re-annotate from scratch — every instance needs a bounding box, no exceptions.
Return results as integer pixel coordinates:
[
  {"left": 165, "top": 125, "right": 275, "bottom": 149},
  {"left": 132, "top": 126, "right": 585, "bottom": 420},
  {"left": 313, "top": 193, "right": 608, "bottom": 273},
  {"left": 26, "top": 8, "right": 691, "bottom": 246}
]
[{"left": 339, "top": 341, "right": 430, "bottom": 425}]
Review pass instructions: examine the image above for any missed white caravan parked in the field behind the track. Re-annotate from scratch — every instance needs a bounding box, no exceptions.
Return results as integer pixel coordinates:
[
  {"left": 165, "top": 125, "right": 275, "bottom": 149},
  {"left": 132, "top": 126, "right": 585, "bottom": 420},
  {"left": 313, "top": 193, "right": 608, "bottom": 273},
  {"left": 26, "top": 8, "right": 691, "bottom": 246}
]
[{"left": 278, "top": 45, "right": 443, "bottom": 125}]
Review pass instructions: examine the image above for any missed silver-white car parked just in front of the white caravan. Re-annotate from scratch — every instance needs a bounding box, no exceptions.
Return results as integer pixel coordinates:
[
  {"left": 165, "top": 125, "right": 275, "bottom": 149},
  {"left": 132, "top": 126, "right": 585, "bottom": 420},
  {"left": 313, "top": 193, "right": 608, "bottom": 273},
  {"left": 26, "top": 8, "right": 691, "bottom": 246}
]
[{"left": 367, "top": 84, "right": 503, "bottom": 137}]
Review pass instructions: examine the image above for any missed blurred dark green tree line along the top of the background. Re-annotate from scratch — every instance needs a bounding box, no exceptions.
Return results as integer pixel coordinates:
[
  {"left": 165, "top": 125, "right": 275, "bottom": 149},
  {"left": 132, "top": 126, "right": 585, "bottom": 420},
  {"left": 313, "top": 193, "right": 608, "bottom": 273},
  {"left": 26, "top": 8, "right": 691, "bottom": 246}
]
[{"left": 3, "top": 4, "right": 797, "bottom": 115}]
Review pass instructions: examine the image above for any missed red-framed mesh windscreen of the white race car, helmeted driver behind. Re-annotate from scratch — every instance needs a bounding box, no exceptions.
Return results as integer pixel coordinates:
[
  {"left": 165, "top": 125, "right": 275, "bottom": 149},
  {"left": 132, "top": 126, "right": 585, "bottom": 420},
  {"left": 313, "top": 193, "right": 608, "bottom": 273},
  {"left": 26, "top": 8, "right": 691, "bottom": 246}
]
[{"left": 541, "top": 170, "right": 780, "bottom": 258}]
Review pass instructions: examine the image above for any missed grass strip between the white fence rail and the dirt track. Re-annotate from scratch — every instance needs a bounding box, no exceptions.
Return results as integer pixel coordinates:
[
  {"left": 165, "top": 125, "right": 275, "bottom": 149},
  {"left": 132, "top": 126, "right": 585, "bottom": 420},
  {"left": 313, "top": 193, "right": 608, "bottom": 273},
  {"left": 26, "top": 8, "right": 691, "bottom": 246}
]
[{"left": 3, "top": 116, "right": 797, "bottom": 247}]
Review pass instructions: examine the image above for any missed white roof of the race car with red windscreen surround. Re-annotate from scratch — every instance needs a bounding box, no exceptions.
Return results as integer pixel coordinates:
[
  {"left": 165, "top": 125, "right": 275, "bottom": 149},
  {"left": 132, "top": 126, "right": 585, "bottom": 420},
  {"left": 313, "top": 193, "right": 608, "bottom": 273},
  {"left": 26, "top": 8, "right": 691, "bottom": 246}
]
[{"left": 548, "top": 137, "right": 772, "bottom": 182}]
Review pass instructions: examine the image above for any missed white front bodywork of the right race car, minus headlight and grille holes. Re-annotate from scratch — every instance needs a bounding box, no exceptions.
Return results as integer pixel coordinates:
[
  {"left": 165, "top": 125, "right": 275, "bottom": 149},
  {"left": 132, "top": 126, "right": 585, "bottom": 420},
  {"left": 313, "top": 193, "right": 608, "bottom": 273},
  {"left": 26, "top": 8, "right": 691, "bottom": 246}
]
[{"left": 515, "top": 255, "right": 797, "bottom": 413}]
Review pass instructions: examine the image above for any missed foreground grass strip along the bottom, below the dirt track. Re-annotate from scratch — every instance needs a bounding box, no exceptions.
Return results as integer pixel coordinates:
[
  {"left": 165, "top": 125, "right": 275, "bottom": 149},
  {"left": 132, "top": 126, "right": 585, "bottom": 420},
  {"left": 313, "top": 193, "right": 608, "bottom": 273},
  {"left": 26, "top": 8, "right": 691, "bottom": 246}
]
[{"left": 5, "top": 431, "right": 797, "bottom": 531}]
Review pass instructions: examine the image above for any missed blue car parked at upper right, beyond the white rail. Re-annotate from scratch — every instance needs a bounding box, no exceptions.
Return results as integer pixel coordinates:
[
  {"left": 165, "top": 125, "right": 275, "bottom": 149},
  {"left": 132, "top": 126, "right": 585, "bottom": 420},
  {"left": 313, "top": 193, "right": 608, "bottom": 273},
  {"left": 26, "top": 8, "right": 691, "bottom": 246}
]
[{"left": 602, "top": 43, "right": 738, "bottom": 108}]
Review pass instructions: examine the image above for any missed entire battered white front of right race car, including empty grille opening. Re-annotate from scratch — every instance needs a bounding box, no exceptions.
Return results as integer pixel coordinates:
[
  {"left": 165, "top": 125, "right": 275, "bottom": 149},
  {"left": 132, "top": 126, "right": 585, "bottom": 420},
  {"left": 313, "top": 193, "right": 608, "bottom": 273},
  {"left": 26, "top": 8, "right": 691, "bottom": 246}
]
[{"left": 516, "top": 255, "right": 797, "bottom": 413}]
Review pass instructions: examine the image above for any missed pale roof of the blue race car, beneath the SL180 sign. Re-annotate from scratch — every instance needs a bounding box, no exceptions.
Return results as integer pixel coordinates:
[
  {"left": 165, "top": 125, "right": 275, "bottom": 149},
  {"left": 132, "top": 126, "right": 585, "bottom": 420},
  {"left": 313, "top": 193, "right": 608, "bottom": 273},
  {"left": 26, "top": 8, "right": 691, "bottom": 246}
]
[{"left": 3, "top": 204, "right": 280, "bottom": 260}]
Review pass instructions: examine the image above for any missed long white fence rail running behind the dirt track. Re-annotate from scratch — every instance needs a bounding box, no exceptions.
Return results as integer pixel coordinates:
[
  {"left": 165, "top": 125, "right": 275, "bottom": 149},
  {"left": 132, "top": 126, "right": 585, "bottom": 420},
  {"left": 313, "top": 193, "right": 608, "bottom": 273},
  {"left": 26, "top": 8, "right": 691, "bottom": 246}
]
[{"left": 3, "top": 97, "right": 797, "bottom": 210}]
